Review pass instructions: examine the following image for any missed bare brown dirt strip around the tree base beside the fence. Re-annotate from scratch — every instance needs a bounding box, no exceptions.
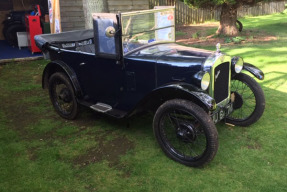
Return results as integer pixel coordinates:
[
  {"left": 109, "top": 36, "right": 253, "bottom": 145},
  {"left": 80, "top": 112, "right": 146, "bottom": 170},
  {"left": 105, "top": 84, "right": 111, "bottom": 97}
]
[{"left": 176, "top": 22, "right": 277, "bottom": 46}]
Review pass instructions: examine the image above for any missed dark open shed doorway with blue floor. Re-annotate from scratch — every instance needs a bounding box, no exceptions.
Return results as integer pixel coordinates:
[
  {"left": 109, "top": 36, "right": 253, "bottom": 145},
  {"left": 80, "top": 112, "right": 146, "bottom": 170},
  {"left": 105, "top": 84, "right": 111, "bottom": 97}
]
[{"left": 0, "top": 0, "right": 50, "bottom": 63}]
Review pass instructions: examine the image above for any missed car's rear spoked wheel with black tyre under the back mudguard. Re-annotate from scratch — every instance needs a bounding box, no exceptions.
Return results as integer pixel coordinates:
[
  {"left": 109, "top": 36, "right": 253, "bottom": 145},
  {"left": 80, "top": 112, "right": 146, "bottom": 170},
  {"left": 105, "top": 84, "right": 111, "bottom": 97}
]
[{"left": 49, "top": 72, "right": 79, "bottom": 119}]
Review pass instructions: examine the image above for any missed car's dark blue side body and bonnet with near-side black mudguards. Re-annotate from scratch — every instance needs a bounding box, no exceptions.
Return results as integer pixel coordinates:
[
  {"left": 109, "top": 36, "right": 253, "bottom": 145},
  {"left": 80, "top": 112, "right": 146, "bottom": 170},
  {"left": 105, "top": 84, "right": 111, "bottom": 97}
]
[{"left": 40, "top": 43, "right": 214, "bottom": 117}]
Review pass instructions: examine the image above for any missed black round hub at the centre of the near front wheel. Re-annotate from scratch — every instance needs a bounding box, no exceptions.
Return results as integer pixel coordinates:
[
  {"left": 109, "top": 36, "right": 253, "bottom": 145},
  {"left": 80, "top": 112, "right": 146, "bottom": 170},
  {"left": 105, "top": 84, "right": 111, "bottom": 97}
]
[{"left": 176, "top": 124, "right": 196, "bottom": 143}]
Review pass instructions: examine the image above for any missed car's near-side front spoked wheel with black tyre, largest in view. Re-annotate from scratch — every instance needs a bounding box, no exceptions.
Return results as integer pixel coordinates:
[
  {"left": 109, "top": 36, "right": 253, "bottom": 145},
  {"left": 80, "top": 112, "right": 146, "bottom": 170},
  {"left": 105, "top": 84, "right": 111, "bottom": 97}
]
[{"left": 153, "top": 99, "right": 218, "bottom": 167}]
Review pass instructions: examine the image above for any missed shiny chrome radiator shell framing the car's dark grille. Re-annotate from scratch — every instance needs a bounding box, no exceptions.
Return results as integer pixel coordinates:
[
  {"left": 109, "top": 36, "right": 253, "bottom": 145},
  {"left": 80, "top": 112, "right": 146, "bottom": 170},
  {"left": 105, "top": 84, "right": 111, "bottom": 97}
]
[{"left": 202, "top": 52, "right": 231, "bottom": 106}]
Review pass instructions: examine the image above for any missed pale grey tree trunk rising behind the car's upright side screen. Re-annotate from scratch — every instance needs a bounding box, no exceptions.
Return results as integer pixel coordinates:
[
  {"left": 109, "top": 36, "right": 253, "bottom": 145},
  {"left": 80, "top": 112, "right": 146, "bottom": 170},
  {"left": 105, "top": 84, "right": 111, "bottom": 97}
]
[{"left": 83, "top": 0, "right": 109, "bottom": 29}]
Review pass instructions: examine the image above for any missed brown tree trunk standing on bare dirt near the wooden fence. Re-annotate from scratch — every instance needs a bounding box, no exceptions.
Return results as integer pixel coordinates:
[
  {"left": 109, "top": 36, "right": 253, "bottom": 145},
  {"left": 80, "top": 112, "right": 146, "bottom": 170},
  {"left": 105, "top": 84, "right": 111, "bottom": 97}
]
[{"left": 216, "top": 3, "right": 238, "bottom": 36}]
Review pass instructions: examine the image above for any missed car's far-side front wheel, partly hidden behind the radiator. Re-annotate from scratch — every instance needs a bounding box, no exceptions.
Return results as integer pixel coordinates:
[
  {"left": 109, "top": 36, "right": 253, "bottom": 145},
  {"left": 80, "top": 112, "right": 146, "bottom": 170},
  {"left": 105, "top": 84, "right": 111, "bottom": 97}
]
[{"left": 226, "top": 73, "right": 265, "bottom": 126}]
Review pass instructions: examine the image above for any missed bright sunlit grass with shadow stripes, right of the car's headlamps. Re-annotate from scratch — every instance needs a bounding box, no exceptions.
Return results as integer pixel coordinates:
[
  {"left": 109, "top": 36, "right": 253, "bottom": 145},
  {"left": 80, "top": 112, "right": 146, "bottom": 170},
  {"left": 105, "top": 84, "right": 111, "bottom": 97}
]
[{"left": 224, "top": 41, "right": 287, "bottom": 93}]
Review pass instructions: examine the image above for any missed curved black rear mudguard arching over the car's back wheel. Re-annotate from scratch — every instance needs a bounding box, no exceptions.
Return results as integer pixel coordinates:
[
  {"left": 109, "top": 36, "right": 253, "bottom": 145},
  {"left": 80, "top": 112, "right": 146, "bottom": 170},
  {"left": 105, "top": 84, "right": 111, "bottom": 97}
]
[{"left": 42, "top": 61, "right": 83, "bottom": 97}]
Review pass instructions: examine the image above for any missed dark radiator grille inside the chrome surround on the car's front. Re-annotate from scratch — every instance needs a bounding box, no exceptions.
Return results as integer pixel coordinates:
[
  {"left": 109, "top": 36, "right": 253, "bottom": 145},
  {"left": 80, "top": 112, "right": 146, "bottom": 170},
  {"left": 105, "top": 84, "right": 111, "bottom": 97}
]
[{"left": 213, "top": 62, "right": 230, "bottom": 103}]
